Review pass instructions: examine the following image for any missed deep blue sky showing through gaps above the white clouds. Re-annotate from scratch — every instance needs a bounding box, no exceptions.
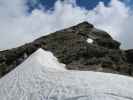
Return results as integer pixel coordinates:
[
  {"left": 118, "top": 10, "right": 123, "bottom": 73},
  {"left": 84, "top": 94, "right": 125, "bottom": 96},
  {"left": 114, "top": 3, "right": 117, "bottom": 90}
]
[{"left": 28, "top": 0, "right": 133, "bottom": 11}]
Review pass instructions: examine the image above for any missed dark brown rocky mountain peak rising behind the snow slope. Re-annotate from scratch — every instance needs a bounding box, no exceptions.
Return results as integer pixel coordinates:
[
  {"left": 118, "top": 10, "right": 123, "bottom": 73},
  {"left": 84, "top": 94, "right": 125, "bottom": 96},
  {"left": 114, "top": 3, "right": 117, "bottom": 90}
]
[{"left": 0, "top": 22, "right": 133, "bottom": 77}]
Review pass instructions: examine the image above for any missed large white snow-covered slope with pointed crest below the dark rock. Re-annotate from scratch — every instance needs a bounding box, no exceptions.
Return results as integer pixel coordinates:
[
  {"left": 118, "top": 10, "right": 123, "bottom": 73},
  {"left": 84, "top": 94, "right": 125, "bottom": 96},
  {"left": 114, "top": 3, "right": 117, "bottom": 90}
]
[{"left": 0, "top": 49, "right": 133, "bottom": 100}]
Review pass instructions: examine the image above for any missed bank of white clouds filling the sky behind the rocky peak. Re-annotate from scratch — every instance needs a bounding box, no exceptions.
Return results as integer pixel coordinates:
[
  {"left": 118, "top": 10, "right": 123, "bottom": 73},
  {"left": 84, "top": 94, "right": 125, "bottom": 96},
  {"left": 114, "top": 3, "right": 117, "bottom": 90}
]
[{"left": 0, "top": 0, "right": 133, "bottom": 50}]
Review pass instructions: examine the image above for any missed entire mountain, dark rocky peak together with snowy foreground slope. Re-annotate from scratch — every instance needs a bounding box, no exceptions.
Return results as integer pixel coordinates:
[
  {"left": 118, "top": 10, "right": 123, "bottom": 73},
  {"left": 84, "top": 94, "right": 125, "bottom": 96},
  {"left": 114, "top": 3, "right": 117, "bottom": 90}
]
[{"left": 0, "top": 22, "right": 133, "bottom": 100}]
